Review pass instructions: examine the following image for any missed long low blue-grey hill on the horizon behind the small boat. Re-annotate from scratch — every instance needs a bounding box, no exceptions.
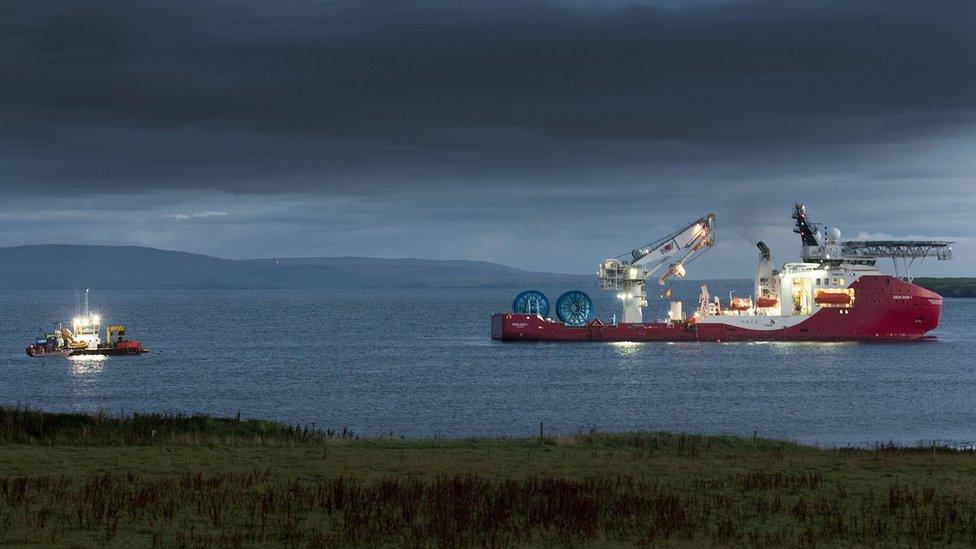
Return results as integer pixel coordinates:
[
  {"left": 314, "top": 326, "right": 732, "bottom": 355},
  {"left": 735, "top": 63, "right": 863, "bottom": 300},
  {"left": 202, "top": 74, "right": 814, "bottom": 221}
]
[{"left": 0, "top": 245, "right": 592, "bottom": 290}]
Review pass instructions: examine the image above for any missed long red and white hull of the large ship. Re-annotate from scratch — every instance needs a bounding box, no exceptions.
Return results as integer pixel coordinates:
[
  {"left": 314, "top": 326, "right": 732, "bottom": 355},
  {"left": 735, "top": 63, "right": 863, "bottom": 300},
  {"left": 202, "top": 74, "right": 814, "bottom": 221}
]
[{"left": 491, "top": 275, "right": 942, "bottom": 342}]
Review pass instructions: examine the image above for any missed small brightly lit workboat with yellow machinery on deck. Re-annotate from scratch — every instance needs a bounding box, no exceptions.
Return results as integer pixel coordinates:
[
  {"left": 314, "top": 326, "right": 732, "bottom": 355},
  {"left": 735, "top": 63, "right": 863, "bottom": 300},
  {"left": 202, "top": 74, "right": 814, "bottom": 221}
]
[{"left": 27, "top": 290, "right": 149, "bottom": 357}]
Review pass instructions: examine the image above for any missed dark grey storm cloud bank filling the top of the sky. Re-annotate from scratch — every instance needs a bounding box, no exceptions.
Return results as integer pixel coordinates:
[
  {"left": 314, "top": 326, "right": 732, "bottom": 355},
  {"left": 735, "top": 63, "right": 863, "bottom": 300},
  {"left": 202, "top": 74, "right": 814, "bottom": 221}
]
[{"left": 0, "top": 0, "right": 976, "bottom": 194}]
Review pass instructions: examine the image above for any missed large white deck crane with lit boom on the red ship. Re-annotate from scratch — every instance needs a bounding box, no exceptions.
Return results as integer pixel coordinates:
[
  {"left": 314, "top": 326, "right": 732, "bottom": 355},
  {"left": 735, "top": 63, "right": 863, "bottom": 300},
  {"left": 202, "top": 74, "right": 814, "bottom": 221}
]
[{"left": 597, "top": 213, "right": 715, "bottom": 324}]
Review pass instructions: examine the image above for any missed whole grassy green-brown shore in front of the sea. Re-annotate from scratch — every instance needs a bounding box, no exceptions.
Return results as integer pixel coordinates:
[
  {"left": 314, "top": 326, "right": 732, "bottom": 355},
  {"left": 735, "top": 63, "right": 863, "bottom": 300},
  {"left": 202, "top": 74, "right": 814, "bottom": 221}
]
[{"left": 0, "top": 407, "right": 976, "bottom": 547}]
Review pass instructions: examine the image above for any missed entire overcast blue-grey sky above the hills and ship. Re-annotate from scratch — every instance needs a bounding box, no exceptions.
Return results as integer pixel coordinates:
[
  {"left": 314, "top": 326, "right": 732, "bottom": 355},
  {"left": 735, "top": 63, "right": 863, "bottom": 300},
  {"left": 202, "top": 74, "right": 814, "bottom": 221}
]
[{"left": 0, "top": 0, "right": 976, "bottom": 278}]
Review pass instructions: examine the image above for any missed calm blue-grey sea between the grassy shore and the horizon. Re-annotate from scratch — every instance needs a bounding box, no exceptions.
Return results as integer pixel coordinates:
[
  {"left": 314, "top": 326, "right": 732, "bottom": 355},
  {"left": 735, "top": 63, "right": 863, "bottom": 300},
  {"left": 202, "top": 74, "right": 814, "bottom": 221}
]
[{"left": 0, "top": 283, "right": 976, "bottom": 445}]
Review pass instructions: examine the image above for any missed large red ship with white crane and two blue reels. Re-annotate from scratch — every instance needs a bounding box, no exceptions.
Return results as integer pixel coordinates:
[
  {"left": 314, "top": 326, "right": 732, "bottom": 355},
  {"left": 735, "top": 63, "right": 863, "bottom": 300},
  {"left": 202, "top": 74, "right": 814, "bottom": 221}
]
[{"left": 491, "top": 204, "right": 952, "bottom": 342}]
